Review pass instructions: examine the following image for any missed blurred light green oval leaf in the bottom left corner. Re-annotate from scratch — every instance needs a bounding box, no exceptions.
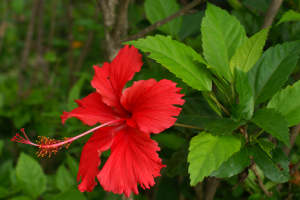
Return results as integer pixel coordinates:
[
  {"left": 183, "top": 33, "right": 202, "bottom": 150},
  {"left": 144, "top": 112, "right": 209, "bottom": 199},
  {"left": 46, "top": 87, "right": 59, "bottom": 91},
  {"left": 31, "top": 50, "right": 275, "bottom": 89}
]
[{"left": 16, "top": 152, "right": 46, "bottom": 199}]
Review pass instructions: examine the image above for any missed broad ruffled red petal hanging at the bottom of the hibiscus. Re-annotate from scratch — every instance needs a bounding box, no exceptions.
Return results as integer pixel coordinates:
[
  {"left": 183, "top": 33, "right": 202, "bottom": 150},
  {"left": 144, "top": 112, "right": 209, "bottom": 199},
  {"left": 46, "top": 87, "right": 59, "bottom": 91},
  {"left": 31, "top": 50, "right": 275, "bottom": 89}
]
[{"left": 97, "top": 127, "right": 165, "bottom": 197}]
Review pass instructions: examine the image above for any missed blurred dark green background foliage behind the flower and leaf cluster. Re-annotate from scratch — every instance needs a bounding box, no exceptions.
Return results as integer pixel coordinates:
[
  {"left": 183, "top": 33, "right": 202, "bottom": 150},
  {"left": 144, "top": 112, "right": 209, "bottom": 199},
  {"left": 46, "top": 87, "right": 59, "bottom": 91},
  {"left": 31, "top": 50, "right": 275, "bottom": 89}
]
[{"left": 0, "top": 0, "right": 300, "bottom": 200}]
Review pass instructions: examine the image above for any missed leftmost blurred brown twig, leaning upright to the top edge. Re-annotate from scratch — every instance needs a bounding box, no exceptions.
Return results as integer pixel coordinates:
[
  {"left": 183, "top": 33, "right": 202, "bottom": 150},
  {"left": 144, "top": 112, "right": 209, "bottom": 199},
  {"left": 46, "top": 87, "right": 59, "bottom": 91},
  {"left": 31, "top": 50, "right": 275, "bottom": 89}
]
[{"left": 18, "top": 0, "right": 38, "bottom": 96}]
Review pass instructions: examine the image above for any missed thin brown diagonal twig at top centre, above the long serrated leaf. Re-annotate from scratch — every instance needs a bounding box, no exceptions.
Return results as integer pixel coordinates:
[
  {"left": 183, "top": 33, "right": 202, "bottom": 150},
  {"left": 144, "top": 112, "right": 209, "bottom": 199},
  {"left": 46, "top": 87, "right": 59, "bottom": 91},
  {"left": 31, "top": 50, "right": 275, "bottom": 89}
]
[{"left": 119, "top": 0, "right": 204, "bottom": 43}]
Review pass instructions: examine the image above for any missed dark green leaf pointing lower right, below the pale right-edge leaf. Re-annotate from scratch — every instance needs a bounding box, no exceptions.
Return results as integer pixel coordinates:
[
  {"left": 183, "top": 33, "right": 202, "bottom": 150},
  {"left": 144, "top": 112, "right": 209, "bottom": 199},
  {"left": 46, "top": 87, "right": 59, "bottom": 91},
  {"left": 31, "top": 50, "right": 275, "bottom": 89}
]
[{"left": 250, "top": 108, "right": 290, "bottom": 147}]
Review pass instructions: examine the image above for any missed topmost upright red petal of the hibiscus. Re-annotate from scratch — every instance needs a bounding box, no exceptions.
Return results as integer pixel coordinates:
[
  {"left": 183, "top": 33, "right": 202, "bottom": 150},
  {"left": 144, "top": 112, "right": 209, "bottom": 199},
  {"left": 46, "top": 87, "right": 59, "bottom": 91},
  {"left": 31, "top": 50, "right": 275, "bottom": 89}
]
[{"left": 91, "top": 45, "right": 143, "bottom": 112}]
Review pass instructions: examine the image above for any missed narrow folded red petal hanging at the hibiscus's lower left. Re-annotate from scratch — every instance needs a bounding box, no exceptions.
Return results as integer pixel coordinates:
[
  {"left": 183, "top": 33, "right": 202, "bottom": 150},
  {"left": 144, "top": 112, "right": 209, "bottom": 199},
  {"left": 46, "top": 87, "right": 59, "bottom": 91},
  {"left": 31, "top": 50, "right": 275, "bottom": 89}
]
[{"left": 77, "top": 126, "right": 119, "bottom": 192}]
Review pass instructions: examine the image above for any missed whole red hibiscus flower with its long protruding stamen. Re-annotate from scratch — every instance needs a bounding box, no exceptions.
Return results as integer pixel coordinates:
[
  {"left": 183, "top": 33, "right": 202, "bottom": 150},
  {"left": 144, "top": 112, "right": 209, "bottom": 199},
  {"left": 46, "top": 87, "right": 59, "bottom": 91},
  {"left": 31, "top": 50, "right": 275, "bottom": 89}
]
[{"left": 13, "top": 45, "right": 184, "bottom": 197}]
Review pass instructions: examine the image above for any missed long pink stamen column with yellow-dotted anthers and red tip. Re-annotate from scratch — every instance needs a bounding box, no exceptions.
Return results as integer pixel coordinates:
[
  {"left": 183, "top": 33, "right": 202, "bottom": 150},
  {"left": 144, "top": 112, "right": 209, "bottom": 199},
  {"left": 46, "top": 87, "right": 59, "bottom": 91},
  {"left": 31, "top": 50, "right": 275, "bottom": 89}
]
[{"left": 11, "top": 119, "right": 126, "bottom": 157}]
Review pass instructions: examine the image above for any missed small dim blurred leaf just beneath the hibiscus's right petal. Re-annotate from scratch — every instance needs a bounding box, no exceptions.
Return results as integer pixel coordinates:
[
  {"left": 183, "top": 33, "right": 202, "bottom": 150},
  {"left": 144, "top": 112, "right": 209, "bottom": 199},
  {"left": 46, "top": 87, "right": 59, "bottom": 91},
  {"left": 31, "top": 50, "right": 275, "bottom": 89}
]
[{"left": 151, "top": 133, "right": 185, "bottom": 150}]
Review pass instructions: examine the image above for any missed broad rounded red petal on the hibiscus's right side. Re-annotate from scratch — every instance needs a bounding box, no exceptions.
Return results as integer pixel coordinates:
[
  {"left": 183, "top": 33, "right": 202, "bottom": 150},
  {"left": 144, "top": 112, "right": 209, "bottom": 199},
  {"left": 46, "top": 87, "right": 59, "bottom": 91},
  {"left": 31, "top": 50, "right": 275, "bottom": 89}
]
[{"left": 121, "top": 79, "right": 184, "bottom": 133}]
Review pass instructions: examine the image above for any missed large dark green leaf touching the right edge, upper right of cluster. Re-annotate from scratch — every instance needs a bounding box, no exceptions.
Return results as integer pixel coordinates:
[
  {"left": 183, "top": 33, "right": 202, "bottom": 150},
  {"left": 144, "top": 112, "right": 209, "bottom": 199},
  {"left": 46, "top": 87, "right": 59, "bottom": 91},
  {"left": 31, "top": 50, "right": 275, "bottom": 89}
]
[{"left": 247, "top": 41, "right": 300, "bottom": 104}]
